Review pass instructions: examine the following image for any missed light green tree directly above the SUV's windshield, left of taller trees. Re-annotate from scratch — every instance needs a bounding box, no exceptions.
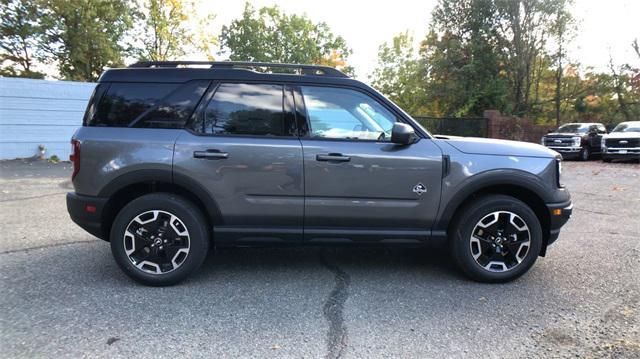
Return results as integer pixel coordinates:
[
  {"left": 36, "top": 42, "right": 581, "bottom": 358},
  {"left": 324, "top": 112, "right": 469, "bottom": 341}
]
[{"left": 369, "top": 32, "right": 428, "bottom": 115}]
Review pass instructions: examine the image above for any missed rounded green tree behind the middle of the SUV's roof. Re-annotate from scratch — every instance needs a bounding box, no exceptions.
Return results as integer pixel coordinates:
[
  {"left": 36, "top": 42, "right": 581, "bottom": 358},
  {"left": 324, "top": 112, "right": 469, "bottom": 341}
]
[{"left": 220, "top": 3, "right": 351, "bottom": 67}]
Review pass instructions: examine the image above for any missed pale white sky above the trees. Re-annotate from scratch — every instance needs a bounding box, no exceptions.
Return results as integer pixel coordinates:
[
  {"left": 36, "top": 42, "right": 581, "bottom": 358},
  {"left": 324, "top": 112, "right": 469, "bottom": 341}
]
[{"left": 196, "top": 0, "right": 640, "bottom": 80}]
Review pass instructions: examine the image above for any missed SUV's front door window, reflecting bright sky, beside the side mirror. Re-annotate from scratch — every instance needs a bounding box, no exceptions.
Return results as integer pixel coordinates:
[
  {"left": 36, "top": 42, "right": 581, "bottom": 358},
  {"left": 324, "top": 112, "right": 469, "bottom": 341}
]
[{"left": 301, "top": 86, "right": 397, "bottom": 141}]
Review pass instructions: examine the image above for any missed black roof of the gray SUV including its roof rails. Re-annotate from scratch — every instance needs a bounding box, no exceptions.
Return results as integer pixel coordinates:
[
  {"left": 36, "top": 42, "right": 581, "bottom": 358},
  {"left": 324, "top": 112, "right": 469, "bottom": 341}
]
[{"left": 98, "top": 61, "right": 364, "bottom": 87}]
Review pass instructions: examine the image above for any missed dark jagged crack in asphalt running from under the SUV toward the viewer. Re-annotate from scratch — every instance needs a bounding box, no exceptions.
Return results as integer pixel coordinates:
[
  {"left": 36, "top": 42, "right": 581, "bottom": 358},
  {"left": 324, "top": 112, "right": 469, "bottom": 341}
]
[{"left": 320, "top": 254, "right": 351, "bottom": 359}]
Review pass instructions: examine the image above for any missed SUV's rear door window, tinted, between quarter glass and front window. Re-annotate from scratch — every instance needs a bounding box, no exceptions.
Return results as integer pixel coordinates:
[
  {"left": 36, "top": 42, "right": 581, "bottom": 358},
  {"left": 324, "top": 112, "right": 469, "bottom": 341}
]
[{"left": 204, "top": 84, "right": 291, "bottom": 136}]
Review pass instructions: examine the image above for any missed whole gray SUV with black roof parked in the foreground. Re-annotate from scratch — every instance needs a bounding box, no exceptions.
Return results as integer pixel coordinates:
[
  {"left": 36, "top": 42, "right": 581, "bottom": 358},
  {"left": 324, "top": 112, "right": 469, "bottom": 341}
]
[{"left": 67, "top": 62, "right": 572, "bottom": 285}]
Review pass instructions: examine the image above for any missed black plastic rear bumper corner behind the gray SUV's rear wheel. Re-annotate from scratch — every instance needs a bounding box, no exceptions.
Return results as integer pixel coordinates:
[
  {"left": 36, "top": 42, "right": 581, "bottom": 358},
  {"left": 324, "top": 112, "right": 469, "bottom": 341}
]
[{"left": 67, "top": 192, "right": 108, "bottom": 240}]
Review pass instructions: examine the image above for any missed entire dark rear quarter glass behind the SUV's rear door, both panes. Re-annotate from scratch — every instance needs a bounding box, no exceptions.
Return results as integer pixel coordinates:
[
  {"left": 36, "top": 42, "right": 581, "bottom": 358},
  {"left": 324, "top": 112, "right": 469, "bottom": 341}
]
[{"left": 85, "top": 81, "right": 209, "bottom": 128}]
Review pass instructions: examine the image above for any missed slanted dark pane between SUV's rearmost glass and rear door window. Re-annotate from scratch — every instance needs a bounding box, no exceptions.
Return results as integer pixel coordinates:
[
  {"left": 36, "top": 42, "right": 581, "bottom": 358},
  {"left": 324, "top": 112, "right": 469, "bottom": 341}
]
[{"left": 131, "top": 81, "right": 209, "bottom": 128}]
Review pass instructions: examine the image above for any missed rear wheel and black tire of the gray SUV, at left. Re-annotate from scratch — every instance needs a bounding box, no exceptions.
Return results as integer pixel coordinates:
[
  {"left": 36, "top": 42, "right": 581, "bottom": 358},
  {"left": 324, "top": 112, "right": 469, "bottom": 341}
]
[{"left": 110, "top": 193, "right": 209, "bottom": 286}]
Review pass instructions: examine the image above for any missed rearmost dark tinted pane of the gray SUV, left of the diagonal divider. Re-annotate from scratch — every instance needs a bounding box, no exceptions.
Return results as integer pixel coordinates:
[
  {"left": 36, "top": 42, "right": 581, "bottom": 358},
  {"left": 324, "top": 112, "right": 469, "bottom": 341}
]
[{"left": 87, "top": 83, "right": 179, "bottom": 127}]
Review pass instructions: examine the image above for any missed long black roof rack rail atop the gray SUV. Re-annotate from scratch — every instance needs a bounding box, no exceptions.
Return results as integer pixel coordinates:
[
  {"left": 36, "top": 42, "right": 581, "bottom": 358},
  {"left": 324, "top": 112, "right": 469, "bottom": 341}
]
[{"left": 129, "top": 61, "right": 349, "bottom": 77}]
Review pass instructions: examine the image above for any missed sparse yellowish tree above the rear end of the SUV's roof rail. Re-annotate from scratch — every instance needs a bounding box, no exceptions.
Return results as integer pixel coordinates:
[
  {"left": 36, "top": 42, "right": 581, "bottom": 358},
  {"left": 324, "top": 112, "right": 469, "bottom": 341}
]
[{"left": 135, "top": 0, "right": 217, "bottom": 61}]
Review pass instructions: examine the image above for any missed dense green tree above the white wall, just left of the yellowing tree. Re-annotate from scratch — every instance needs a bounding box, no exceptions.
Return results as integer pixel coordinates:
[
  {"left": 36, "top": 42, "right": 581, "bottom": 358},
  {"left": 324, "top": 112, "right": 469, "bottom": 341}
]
[{"left": 40, "top": 0, "right": 133, "bottom": 81}]
